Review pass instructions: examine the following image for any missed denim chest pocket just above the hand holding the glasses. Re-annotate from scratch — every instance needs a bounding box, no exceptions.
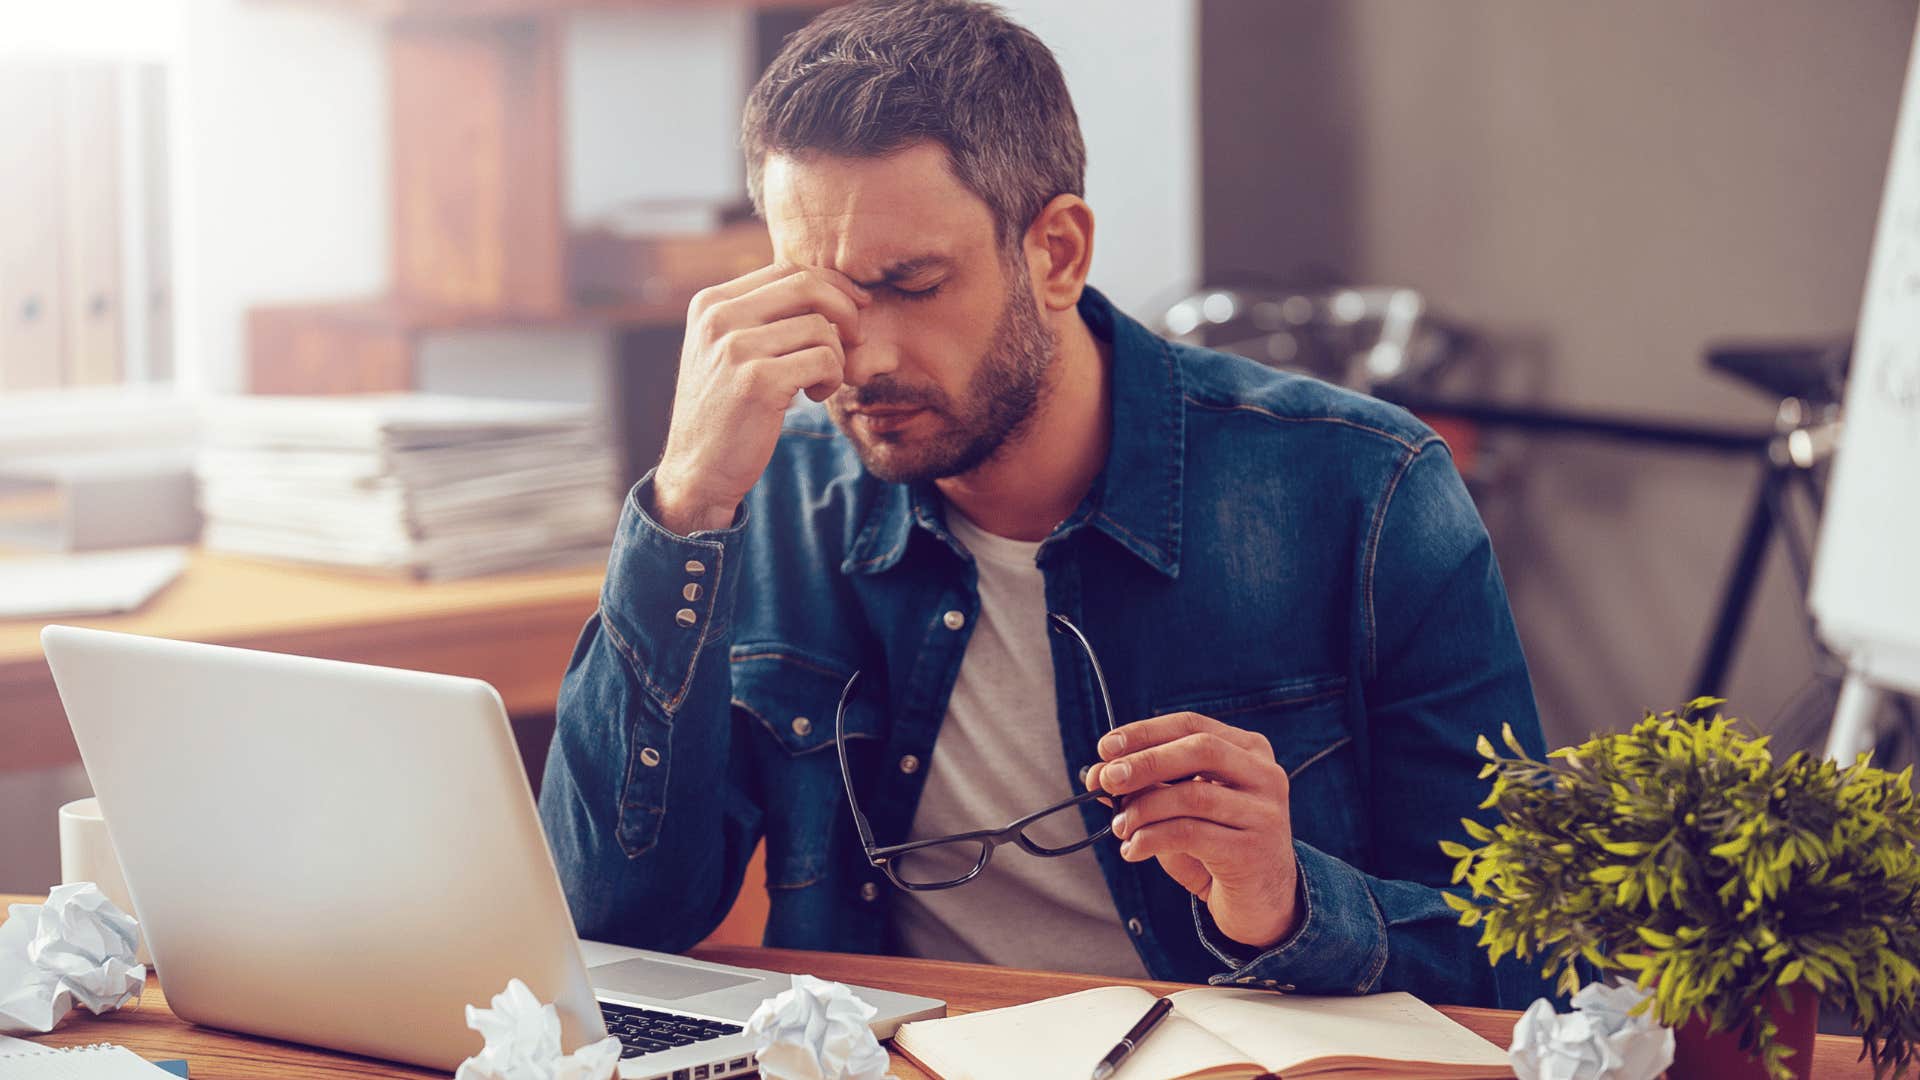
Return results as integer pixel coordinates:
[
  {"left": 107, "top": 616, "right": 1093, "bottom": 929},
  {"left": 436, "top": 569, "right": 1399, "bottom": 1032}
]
[{"left": 1154, "top": 675, "right": 1367, "bottom": 865}]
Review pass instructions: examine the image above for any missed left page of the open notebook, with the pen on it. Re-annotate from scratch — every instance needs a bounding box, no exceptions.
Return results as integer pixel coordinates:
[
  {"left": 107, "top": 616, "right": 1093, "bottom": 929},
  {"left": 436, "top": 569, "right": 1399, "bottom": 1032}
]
[{"left": 893, "top": 986, "right": 1260, "bottom": 1080}]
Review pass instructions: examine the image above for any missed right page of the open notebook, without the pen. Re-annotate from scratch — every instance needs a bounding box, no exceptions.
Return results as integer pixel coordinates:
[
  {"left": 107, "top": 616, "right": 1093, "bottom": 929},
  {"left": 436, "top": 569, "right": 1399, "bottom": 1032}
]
[{"left": 1171, "top": 988, "right": 1509, "bottom": 1072}]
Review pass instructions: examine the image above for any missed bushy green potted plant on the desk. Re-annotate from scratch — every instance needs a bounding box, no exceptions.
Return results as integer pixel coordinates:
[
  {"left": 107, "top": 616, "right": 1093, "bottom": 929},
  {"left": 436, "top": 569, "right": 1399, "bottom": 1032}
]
[{"left": 1442, "top": 698, "right": 1920, "bottom": 1080}]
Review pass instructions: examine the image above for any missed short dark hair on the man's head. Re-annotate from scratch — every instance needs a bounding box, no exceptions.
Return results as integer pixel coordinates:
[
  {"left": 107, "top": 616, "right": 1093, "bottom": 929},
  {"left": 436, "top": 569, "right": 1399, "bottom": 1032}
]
[{"left": 741, "top": 0, "right": 1087, "bottom": 244}]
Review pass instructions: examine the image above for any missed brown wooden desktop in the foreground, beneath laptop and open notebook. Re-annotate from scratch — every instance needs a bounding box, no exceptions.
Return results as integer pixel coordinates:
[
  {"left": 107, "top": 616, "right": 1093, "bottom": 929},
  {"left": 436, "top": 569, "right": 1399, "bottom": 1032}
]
[{"left": 0, "top": 896, "right": 1874, "bottom": 1080}]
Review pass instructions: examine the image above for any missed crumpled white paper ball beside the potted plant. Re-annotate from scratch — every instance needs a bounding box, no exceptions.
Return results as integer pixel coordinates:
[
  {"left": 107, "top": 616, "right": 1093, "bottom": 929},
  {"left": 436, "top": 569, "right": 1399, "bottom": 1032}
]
[{"left": 1507, "top": 982, "right": 1674, "bottom": 1080}]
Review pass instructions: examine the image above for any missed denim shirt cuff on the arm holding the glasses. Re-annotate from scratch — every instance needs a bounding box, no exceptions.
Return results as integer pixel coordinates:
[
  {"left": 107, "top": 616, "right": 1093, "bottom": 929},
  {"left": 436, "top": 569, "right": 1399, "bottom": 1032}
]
[{"left": 1192, "top": 840, "right": 1386, "bottom": 994}]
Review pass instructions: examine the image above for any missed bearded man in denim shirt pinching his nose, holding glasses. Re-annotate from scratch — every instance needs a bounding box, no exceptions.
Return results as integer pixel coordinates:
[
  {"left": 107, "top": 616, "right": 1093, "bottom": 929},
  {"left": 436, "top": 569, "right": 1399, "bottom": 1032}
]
[{"left": 541, "top": 0, "right": 1542, "bottom": 1005}]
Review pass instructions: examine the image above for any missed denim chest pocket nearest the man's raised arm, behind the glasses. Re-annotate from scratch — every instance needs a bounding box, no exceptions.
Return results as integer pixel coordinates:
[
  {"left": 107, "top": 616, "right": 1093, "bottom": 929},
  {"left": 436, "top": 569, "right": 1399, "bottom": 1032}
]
[{"left": 730, "top": 648, "right": 879, "bottom": 890}]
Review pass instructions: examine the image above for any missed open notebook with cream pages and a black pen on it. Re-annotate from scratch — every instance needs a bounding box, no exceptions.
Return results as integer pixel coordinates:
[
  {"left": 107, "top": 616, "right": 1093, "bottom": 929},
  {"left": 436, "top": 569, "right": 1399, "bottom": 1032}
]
[{"left": 893, "top": 986, "right": 1513, "bottom": 1080}]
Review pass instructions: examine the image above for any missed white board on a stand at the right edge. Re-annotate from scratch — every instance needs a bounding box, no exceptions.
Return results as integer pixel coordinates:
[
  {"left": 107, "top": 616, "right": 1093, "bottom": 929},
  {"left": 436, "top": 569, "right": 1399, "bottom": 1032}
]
[{"left": 1809, "top": 12, "right": 1920, "bottom": 694}]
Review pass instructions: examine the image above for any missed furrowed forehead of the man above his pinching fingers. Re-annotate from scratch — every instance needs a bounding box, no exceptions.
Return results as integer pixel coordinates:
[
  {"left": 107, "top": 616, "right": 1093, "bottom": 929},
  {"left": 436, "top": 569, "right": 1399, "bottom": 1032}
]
[{"left": 760, "top": 142, "right": 995, "bottom": 281}]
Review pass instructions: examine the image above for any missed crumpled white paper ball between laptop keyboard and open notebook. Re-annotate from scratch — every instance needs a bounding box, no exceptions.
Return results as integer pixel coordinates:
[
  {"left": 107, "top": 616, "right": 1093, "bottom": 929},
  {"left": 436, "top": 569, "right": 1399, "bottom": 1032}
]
[{"left": 747, "top": 974, "right": 887, "bottom": 1080}]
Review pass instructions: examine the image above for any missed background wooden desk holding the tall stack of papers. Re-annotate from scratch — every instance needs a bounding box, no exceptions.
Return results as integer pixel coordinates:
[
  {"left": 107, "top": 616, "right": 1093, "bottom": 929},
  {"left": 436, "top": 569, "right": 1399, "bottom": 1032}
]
[{"left": 0, "top": 552, "right": 605, "bottom": 773}]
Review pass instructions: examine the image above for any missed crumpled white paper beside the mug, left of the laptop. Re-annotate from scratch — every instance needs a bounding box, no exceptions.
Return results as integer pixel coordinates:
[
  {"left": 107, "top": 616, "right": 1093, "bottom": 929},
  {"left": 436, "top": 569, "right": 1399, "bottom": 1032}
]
[{"left": 0, "top": 882, "right": 146, "bottom": 1036}]
